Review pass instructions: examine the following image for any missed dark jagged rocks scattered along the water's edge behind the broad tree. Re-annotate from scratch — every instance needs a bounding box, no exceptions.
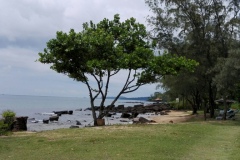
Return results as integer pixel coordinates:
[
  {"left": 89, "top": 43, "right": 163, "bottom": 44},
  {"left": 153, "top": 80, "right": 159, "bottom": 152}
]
[{"left": 26, "top": 103, "right": 171, "bottom": 128}]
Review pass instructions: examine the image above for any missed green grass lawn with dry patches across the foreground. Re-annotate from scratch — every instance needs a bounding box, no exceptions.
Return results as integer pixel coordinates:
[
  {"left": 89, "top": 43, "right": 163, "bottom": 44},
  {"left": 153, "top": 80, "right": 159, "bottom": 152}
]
[{"left": 0, "top": 116, "right": 240, "bottom": 160}]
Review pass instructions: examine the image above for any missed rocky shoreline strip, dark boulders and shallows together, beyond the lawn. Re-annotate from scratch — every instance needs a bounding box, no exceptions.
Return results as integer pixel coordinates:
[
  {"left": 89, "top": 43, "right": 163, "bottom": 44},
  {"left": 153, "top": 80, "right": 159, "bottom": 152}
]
[{"left": 19, "top": 103, "right": 171, "bottom": 132}]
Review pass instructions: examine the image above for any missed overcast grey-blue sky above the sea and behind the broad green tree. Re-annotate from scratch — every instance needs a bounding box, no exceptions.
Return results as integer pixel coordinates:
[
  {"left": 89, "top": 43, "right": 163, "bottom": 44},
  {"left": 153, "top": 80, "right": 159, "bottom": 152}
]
[{"left": 0, "top": 0, "right": 161, "bottom": 97}]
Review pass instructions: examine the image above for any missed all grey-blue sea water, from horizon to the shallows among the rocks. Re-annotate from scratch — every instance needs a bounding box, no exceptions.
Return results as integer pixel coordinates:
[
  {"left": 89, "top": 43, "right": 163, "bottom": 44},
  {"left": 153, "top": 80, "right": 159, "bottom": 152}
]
[{"left": 0, "top": 95, "right": 147, "bottom": 131}]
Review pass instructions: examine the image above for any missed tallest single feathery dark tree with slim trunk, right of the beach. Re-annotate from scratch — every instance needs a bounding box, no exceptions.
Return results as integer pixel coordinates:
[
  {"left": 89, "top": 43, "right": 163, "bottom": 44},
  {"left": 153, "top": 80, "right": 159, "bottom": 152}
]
[{"left": 146, "top": 0, "right": 240, "bottom": 117}]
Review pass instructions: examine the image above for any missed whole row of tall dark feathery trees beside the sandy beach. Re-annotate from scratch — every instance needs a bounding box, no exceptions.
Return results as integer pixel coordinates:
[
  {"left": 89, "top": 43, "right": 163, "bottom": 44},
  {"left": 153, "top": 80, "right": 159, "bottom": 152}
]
[{"left": 146, "top": 0, "right": 240, "bottom": 118}]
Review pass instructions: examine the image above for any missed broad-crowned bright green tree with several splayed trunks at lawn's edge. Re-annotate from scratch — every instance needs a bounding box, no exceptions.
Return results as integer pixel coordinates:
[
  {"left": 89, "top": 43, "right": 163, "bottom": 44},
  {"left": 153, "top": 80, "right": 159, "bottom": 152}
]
[{"left": 38, "top": 15, "right": 196, "bottom": 125}]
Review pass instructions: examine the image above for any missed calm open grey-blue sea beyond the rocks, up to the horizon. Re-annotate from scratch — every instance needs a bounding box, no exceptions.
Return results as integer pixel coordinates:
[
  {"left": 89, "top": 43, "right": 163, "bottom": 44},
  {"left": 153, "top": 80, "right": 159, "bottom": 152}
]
[{"left": 0, "top": 95, "right": 146, "bottom": 116}]
